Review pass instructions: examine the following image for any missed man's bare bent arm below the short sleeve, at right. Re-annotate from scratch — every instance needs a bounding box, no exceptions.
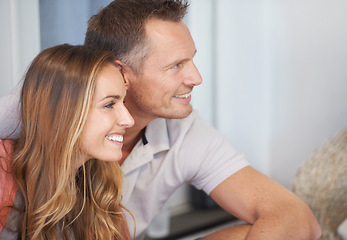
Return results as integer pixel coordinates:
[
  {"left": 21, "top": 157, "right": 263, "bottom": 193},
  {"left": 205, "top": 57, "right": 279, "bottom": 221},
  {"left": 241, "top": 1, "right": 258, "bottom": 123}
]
[{"left": 204, "top": 167, "right": 321, "bottom": 240}]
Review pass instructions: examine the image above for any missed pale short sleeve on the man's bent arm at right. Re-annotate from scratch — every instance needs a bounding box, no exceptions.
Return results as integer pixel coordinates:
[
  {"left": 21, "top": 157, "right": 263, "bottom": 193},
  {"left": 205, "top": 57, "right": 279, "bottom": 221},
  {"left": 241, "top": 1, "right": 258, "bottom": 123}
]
[{"left": 179, "top": 116, "right": 249, "bottom": 194}]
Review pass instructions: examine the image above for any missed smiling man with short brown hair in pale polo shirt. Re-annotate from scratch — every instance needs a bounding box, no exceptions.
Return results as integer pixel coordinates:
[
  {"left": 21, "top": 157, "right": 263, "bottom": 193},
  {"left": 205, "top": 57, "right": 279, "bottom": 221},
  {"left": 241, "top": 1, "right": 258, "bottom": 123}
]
[{"left": 0, "top": 0, "right": 320, "bottom": 240}]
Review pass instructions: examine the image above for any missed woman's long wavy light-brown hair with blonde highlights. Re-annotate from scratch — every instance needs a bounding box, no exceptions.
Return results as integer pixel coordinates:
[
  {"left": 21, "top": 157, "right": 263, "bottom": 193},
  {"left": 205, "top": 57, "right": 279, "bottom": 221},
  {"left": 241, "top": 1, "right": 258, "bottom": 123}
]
[{"left": 12, "top": 44, "right": 127, "bottom": 240}]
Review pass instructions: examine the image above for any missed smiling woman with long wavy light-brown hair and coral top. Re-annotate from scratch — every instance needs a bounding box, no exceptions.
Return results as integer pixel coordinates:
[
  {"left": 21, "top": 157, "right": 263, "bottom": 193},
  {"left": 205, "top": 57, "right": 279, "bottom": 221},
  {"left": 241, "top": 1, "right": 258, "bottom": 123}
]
[{"left": 0, "top": 45, "right": 134, "bottom": 240}]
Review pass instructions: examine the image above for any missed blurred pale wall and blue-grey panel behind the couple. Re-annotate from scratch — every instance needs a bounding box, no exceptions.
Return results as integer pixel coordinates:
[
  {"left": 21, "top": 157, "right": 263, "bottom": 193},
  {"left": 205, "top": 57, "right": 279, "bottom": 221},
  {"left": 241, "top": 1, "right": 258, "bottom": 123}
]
[{"left": 0, "top": 0, "right": 347, "bottom": 236}]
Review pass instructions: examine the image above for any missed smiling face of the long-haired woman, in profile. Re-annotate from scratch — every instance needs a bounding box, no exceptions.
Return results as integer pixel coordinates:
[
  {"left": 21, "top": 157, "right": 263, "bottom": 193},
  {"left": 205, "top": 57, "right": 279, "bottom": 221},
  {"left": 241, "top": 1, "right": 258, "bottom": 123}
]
[{"left": 82, "top": 64, "right": 134, "bottom": 166}]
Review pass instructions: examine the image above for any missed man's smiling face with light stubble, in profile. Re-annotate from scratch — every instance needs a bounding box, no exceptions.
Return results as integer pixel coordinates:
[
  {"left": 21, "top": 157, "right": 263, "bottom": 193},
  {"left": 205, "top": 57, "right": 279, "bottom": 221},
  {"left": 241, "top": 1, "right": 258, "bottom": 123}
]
[{"left": 127, "top": 19, "right": 202, "bottom": 120}]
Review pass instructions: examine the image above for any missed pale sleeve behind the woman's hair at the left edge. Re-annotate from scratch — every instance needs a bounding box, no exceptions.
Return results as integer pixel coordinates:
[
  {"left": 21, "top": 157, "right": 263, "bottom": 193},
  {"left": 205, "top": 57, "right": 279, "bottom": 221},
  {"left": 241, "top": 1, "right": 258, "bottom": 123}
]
[{"left": 0, "top": 87, "right": 20, "bottom": 139}]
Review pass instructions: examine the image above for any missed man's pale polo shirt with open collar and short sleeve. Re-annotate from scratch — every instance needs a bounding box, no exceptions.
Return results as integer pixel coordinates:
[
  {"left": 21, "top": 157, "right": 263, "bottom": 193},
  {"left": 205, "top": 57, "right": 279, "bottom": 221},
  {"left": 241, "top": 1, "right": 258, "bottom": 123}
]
[{"left": 122, "top": 111, "right": 249, "bottom": 239}]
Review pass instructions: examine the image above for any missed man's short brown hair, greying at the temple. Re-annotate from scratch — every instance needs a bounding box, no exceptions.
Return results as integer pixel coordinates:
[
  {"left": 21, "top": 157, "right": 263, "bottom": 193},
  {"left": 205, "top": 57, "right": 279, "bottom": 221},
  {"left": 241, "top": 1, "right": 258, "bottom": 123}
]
[{"left": 84, "top": 0, "right": 189, "bottom": 71}]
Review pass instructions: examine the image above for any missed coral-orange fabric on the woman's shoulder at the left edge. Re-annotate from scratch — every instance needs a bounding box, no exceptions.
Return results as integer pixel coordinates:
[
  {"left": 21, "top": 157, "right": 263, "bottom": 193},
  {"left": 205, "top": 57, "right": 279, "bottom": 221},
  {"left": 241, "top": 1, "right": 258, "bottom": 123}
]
[{"left": 0, "top": 140, "right": 17, "bottom": 231}]
